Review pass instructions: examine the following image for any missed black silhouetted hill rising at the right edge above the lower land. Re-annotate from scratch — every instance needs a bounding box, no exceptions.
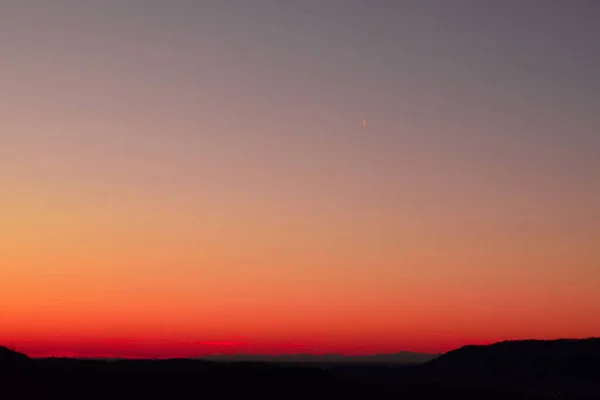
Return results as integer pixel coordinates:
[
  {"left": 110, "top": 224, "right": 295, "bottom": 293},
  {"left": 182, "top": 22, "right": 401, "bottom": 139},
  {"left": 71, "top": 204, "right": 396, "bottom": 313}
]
[{"left": 411, "top": 338, "right": 600, "bottom": 395}]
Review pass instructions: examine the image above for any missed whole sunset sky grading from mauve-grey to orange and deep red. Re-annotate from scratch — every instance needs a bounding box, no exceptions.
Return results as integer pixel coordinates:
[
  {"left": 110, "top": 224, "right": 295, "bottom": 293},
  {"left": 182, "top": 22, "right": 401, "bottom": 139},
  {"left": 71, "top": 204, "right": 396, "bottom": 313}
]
[{"left": 0, "top": 0, "right": 600, "bottom": 357}]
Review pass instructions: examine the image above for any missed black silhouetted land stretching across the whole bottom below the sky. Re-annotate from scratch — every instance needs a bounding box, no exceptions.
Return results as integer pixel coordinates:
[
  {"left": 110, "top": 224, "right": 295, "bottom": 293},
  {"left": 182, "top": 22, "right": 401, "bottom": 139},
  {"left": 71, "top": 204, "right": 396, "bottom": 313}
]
[{"left": 0, "top": 339, "right": 600, "bottom": 399}]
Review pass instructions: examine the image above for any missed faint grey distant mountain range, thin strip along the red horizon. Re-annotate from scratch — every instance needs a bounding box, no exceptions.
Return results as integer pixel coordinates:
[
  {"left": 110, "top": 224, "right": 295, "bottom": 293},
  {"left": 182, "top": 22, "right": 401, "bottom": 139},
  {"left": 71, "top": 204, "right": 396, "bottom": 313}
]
[{"left": 202, "top": 351, "right": 439, "bottom": 364}]
